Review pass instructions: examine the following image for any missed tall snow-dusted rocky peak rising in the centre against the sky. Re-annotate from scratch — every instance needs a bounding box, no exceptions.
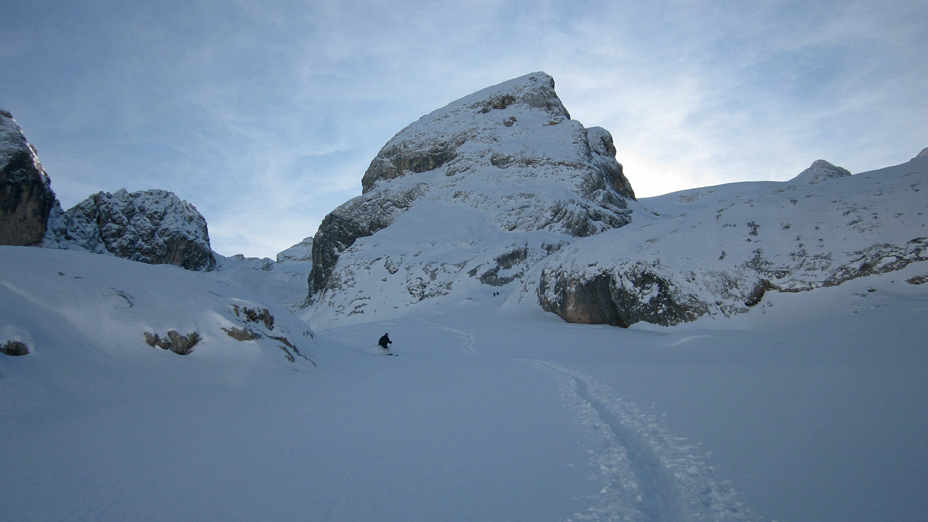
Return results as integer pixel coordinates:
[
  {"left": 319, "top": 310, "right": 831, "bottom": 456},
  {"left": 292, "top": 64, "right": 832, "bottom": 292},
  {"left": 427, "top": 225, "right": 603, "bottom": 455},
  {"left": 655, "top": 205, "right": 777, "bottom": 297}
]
[{"left": 309, "top": 73, "right": 634, "bottom": 313}]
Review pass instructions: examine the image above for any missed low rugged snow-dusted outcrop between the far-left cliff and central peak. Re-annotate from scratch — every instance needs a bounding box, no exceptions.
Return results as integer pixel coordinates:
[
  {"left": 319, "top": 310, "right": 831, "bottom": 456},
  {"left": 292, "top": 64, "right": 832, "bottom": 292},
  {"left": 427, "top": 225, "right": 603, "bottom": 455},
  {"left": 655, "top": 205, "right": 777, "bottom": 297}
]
[{"left": 43, "top": 189, "right": 216, "bottom": 270}]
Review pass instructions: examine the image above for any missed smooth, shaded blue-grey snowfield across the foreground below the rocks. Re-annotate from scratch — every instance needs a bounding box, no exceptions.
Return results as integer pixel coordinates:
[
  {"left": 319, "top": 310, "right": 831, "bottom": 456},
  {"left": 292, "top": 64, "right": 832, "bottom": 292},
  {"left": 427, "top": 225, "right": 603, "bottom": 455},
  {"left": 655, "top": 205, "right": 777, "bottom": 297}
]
[{"left": 0, "top": 241, "right": 928, "bottom": 521}]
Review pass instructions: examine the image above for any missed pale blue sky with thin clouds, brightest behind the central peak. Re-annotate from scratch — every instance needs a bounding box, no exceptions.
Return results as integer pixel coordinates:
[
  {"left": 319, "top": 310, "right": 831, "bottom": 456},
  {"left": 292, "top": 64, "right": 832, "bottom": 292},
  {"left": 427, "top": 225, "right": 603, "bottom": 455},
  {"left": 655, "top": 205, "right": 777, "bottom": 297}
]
[{"left": 0, "top": 0, "right": 928, "bottom": 258}]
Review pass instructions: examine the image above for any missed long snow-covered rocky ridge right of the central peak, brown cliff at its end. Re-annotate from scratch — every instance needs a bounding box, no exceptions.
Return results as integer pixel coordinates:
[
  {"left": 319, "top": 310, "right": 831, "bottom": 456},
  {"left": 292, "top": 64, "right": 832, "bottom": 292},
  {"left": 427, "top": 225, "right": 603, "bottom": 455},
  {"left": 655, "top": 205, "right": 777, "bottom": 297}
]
[{"left": 537, "top": 151, "right": 928, "bottom": 326}]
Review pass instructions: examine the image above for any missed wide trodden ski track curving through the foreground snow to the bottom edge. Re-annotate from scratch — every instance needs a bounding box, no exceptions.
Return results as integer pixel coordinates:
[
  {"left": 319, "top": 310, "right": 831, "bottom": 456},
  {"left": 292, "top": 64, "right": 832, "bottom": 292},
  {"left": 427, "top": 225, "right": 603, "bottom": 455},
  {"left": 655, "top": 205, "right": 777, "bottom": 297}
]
[{"left": 526, "top": 360, "right": 751, "bottom": 522}]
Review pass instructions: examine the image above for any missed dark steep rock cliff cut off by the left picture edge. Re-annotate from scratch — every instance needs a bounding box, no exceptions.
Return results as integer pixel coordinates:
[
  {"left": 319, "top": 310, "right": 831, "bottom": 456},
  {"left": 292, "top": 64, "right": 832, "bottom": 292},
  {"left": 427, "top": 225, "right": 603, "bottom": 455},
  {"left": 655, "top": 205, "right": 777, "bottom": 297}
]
[{"left": 0, "top": 109, "right": 55, "bottom": 245}]
